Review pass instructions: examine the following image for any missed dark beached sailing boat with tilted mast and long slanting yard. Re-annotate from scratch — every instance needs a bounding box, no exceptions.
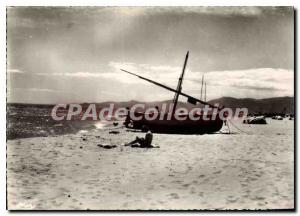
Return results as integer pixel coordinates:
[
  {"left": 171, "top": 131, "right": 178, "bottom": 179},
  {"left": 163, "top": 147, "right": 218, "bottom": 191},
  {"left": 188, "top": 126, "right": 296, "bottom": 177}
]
[{"left": 121, "top": 51, "right": 223, "bottom": 134}]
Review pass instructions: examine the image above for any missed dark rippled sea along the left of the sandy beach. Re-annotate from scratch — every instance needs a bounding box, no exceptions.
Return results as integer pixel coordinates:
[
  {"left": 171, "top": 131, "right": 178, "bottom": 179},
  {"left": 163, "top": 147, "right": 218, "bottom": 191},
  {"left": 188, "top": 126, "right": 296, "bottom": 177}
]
[{"left": 6, "top": 105, "right": 95, "bottom": 139}]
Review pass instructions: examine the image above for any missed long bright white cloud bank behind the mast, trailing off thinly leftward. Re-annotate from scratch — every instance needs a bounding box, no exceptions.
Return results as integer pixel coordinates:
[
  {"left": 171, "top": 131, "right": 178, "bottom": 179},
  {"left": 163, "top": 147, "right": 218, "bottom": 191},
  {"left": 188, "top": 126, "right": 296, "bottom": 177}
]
[{"left": 11, "top": 61, "right": 294, "bottom": 100}]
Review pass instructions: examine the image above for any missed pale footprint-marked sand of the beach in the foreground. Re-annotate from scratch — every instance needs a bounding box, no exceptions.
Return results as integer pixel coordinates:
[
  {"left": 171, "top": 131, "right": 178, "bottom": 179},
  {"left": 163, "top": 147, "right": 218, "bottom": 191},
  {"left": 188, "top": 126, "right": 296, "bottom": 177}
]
[{"left": 7, "top": 119, "right": 294, "bottom": 210}]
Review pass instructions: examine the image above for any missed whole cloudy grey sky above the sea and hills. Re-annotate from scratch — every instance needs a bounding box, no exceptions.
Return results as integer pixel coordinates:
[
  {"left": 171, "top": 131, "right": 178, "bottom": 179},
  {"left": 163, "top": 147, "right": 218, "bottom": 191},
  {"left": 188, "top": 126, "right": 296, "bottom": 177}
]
[{"left": 7, "top": 7, "right": 294, "bottom": 104}]
